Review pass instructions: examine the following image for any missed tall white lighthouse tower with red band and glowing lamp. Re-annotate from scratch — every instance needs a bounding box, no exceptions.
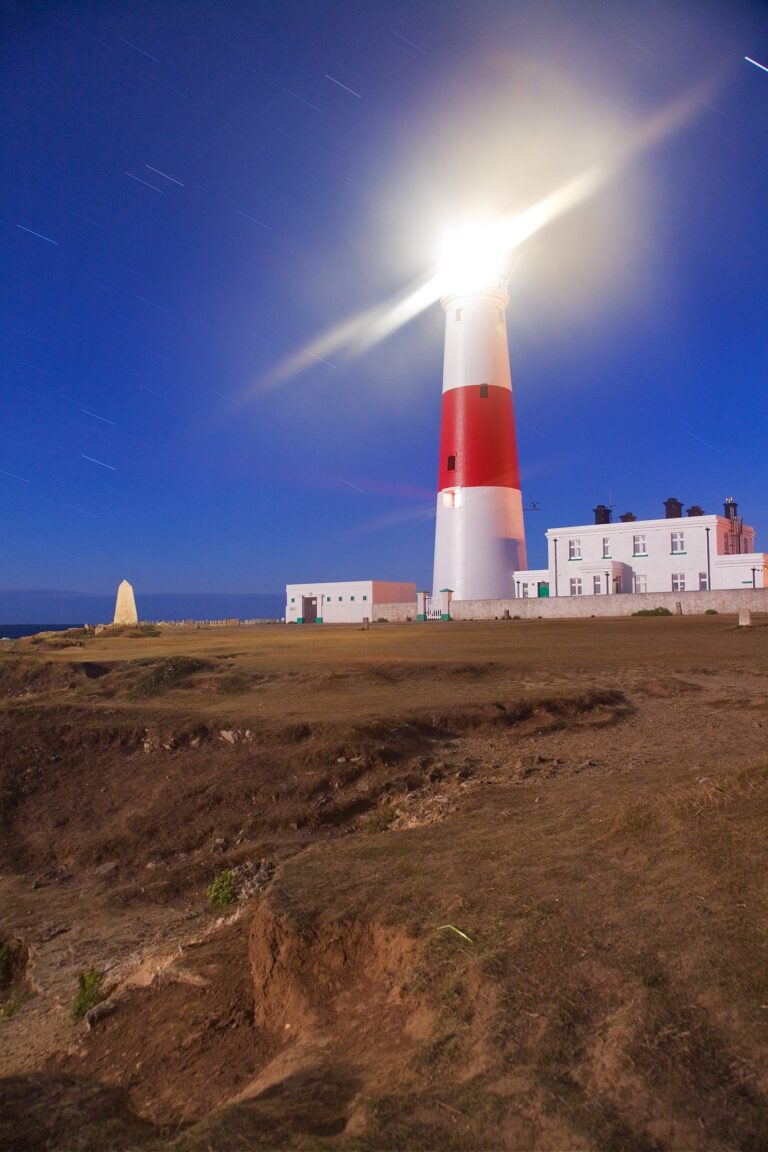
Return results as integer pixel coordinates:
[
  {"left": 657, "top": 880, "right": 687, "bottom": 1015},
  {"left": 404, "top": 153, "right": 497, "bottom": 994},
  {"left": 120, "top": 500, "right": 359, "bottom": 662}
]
[{"left": 433, "top": 229, "right": 526, "bottom": 600}]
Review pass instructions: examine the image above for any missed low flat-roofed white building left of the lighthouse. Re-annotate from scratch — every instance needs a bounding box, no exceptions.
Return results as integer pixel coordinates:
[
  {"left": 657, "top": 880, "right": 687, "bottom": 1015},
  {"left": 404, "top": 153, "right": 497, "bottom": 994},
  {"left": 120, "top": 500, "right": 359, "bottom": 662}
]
[{"left": 286, "top": 579, "right": 416, "bottom": 624}]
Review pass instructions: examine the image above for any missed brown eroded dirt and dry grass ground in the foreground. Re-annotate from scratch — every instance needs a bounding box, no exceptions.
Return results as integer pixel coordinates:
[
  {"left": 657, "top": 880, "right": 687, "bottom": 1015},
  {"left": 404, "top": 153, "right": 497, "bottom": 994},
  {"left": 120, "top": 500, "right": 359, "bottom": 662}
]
[{"left": 0, "top": 616, "right": 768, "bottom": 1152}]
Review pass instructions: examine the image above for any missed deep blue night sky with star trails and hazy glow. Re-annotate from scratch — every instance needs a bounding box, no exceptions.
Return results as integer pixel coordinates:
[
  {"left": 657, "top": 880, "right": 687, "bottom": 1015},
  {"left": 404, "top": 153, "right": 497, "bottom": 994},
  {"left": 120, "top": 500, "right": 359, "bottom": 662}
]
[{"left": 0, "top": 0, "right": 768, "bottom": 620}]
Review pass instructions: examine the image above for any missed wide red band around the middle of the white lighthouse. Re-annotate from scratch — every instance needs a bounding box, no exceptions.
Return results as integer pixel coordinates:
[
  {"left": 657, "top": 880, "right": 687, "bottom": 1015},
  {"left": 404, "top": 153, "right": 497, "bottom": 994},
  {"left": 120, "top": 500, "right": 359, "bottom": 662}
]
[{"left": 438, "top": 384, "right": 520, "bottom": 492}]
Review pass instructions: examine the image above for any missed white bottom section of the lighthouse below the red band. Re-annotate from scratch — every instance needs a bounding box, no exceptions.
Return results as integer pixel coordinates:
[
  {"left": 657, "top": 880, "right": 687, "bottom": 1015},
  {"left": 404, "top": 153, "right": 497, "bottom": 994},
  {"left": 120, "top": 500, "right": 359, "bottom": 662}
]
[{"left": 432, "top": 487, "right": 526, "bottom": 600}]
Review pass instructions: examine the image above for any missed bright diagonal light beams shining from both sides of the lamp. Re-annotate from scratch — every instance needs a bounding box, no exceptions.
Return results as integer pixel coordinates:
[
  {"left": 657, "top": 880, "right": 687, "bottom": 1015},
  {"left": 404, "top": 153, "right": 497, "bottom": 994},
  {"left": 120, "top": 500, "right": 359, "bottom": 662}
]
[{"left": 253, "top": 77, "right": 723, "bottom": 395}]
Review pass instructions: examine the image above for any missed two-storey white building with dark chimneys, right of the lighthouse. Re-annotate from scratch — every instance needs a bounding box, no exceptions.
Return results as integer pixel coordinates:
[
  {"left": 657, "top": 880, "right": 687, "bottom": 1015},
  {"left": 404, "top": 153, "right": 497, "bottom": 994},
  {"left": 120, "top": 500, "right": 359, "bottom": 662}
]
[{"left": 515, "top": 499, "right": 768, "bottom": 597}]
